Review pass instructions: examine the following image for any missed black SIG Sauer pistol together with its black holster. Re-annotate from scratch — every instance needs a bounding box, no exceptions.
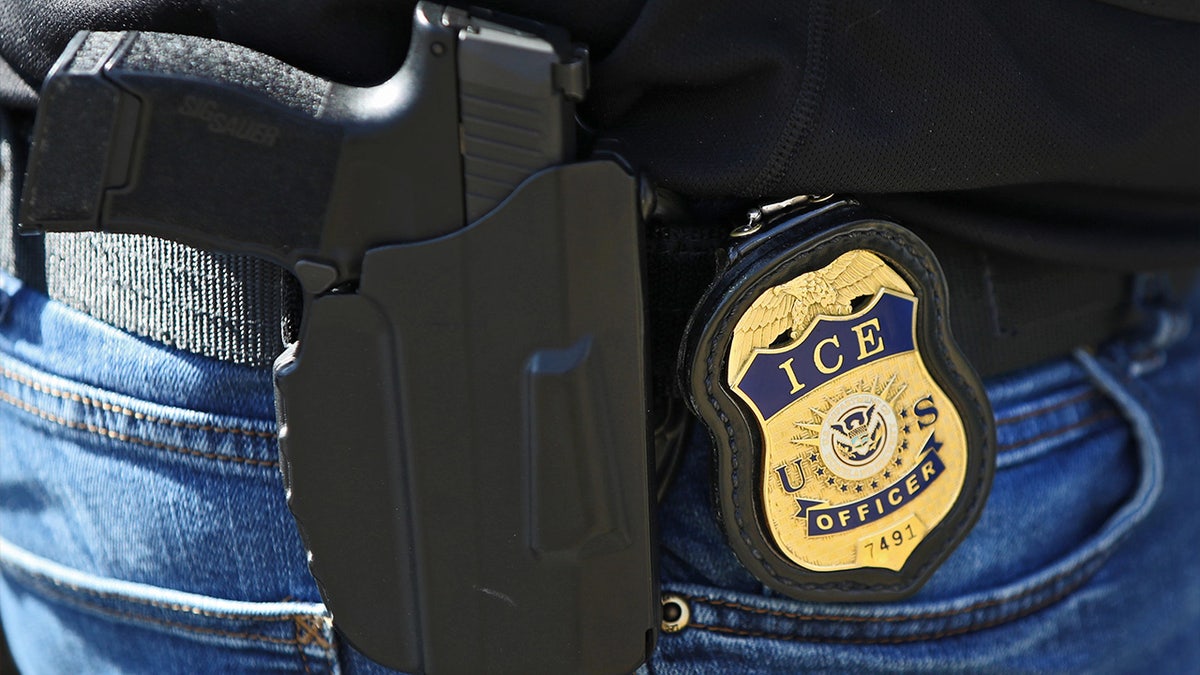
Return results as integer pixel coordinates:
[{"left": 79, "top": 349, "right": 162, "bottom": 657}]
[{"left": 20, "top": 2, "right": 659, "bottom": 673}]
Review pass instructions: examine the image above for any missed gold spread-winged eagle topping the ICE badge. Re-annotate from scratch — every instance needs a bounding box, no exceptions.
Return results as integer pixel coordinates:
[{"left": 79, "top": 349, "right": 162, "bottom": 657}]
[{"left": 730, "top": 251, "right": 912, "bottom": 375}]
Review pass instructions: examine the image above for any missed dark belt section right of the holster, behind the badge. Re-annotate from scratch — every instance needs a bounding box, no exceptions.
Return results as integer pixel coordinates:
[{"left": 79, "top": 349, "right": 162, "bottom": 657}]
[{"left": 648, "top": 207, "right": 1194, "bottom": 396}]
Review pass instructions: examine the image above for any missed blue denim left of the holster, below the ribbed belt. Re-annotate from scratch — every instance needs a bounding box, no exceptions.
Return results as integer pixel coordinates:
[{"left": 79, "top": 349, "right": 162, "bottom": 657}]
[{"left": 0, "top": 282, "right": 337, "bottom": 674}]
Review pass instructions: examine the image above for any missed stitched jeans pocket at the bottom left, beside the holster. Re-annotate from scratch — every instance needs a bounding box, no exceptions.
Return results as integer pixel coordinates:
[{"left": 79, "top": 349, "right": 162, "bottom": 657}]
[{"left": 0, "top": 542, "right": 336, "bottom": 673}]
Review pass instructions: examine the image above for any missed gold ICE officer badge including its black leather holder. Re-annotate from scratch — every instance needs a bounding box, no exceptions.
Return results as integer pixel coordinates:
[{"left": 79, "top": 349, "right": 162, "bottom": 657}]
[{"left": 680, "top": 202, "right": 995, "bottom": 601}]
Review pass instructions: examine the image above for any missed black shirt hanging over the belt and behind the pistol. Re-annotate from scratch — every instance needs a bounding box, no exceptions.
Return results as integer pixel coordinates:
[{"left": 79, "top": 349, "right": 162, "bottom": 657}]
[{"left": 0, "top": 0, "right": 1200, "bottom": 269}]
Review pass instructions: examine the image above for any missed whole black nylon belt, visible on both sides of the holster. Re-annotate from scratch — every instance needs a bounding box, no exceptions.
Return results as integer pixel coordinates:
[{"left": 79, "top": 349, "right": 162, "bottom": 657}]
[{"left": 0, "top": 111, "right": 1188, "bottom": 381}]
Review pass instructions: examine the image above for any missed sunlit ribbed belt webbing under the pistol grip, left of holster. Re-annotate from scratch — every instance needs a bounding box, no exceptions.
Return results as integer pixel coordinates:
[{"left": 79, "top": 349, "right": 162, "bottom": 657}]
[{"left": 0, "top": 112, "right": 300, "bottom": 366}]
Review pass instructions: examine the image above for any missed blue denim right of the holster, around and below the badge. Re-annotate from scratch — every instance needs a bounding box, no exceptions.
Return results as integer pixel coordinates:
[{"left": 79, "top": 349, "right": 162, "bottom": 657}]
[{"left": 643, "top": 288, "right": 1200, "bottom": 674}]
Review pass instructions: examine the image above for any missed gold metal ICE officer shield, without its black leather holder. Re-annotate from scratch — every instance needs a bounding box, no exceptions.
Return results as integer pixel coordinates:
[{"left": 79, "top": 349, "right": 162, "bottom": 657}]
[{"left": 730, "top": 250, "right": 966, "bottom": 571}]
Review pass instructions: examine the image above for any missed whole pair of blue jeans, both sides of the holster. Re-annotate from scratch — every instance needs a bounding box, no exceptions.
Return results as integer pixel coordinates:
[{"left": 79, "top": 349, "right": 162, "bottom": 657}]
[{"left": 0, "top": 265, "right": 1200, "bottom": 674}]
